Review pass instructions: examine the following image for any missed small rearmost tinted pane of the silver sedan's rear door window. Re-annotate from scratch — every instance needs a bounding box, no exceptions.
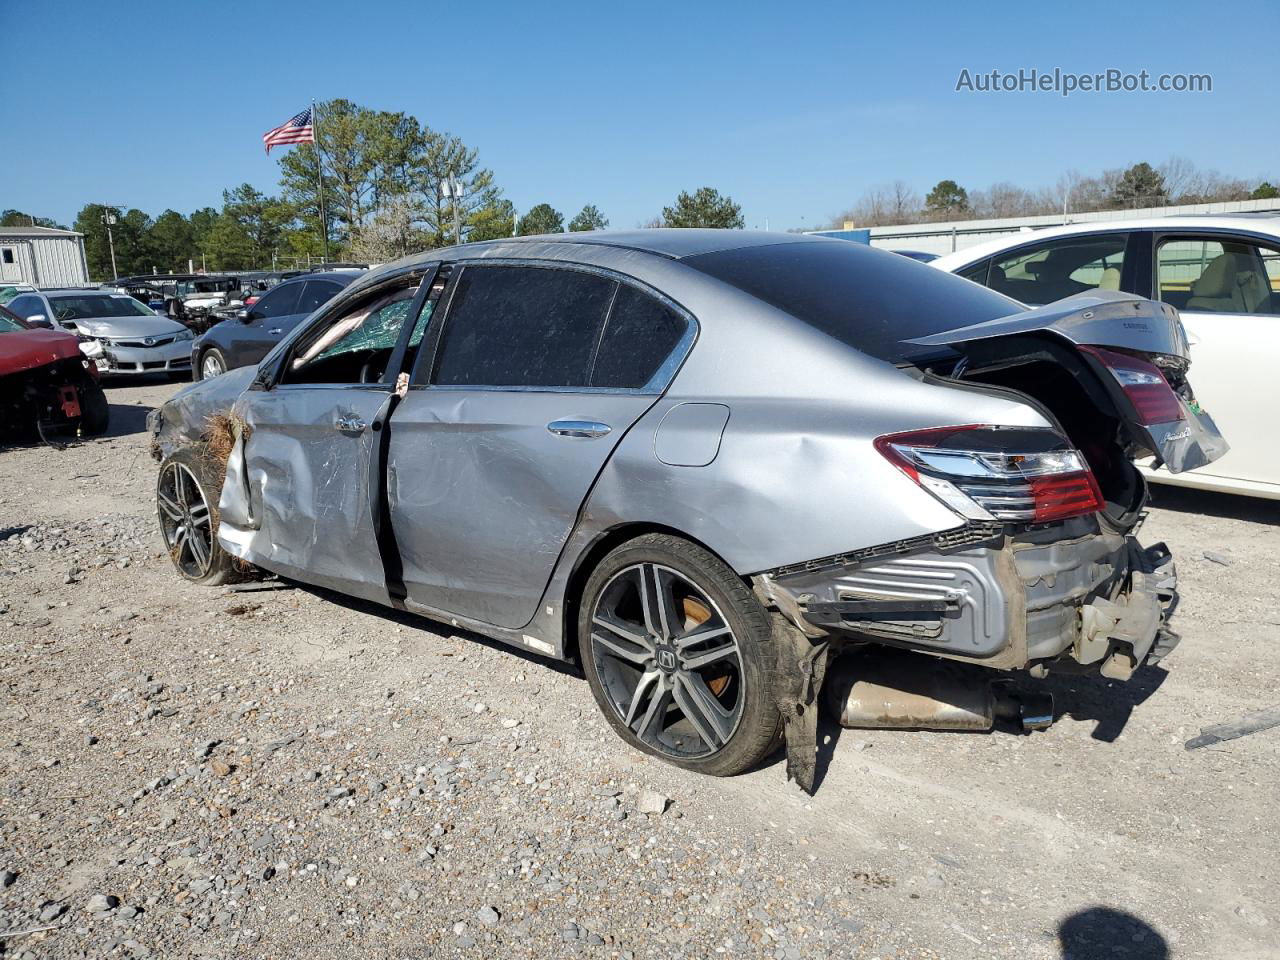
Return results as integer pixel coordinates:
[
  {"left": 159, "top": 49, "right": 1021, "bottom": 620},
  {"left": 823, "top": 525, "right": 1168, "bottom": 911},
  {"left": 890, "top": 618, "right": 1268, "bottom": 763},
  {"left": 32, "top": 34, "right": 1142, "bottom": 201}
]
[{"left": 591, "top": 284, "right": 687, "bottom": 389}]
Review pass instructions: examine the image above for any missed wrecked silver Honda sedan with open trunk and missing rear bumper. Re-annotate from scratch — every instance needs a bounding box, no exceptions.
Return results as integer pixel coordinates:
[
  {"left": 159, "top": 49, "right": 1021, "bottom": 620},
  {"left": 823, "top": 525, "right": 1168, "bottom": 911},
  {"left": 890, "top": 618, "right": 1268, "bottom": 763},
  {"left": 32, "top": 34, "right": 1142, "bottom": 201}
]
[{"left": 150, "top": 230, "right": 1226, "bottom": 787}]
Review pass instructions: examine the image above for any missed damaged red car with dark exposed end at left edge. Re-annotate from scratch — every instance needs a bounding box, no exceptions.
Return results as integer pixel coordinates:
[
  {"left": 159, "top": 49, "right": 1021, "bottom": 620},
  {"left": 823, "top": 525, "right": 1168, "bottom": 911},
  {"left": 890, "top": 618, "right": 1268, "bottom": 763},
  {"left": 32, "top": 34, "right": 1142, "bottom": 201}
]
[{"left": 0, "top": 307, "right": 110, "bottom": 436}]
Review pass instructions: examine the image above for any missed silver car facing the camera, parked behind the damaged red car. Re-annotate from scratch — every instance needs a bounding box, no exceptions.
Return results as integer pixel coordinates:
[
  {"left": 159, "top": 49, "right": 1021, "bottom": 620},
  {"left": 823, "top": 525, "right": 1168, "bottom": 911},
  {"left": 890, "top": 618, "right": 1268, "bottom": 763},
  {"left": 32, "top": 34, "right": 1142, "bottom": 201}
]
[{"left": 9, "top": 288, "right": 192, "bottom": 375}]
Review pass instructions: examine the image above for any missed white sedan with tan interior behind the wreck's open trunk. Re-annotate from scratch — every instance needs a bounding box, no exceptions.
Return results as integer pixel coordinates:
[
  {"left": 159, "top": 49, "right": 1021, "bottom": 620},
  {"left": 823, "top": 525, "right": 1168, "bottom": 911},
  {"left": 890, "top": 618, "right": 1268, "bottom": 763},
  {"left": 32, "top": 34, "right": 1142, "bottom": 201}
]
[{"left": 929, "top": 214, "right": 1280, "bottom": 499}]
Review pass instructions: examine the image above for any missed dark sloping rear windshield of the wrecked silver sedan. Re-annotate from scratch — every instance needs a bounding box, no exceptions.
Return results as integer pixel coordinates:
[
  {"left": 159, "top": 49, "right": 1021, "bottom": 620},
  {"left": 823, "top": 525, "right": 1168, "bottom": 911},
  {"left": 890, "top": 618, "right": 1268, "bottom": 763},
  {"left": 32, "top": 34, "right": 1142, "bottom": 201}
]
[{"left": 681, "top": 239, "right": 1025, "bottom": 364}]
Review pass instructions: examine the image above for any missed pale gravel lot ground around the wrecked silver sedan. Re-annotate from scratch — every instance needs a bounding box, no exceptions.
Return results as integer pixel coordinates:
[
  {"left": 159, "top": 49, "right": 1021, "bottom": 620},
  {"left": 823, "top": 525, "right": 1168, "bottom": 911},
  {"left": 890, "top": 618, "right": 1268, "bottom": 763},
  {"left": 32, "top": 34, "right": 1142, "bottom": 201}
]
[{"left": 0, "top": 381, "right": 1280, "bottom": 960}]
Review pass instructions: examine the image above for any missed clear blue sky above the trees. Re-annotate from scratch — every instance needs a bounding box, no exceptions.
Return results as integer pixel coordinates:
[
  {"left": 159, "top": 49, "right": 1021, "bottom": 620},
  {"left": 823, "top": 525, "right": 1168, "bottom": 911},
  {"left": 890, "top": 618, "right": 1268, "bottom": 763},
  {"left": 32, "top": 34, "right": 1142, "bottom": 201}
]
[{"left": 0, "top": 0, "right": 1280, "bottom": 229}]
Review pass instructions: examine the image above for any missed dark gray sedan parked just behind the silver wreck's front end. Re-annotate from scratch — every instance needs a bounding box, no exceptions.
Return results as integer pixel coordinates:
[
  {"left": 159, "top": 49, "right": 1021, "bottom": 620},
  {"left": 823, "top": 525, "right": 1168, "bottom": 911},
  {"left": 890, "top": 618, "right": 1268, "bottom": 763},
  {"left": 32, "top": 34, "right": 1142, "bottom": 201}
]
[{"left": 191, "top": 273, "right": 361, "bottom": 380}]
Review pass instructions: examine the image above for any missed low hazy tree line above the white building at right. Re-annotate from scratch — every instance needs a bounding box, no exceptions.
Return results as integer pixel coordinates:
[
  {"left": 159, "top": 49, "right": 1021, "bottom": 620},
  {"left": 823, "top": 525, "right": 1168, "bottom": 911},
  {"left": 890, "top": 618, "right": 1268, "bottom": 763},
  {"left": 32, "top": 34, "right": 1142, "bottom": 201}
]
[{"left": 832, "top": 156, "right": 1280, "bottom": 227}]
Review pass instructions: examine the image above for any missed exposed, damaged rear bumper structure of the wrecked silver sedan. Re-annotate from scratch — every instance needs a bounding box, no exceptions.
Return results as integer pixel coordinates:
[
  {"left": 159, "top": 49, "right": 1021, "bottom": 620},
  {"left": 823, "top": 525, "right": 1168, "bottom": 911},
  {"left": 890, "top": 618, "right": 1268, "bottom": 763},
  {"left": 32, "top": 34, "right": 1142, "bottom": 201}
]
[{"left": 760, "top": 518, "right": 1178, "bottom": 680}]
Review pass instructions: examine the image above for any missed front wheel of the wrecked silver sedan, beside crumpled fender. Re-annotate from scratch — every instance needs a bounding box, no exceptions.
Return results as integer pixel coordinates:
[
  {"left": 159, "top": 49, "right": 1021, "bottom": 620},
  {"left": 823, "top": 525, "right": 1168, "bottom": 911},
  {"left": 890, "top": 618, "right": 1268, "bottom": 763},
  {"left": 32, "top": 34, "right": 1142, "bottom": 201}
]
[{"left": 156, "top": 444, "right": 242, "bottom": 586}]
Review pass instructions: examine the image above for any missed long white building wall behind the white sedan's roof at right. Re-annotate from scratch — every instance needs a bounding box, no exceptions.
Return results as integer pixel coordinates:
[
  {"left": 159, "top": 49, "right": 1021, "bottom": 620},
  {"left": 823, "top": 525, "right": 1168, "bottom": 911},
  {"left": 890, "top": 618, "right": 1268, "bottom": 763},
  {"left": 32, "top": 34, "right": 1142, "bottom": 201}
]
[{"left": 855, "top": 200, "right": 1280, "bottom": 256}]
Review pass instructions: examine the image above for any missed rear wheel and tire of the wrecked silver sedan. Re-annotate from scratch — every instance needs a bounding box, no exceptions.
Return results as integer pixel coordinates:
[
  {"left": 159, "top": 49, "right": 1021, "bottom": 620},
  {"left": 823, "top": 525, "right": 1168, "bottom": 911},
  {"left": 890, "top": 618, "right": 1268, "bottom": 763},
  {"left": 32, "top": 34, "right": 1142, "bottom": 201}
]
[{"left": 577, "top": 534, "right": 782, "bottom": 777}]
